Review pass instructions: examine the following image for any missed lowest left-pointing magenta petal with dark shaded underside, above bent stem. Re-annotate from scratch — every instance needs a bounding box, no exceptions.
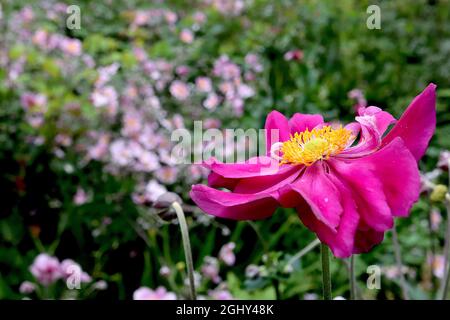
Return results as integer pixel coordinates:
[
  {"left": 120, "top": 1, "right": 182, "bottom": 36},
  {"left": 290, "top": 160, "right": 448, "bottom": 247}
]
[{"left": 190, "top": 185, "right": 278, "bottom": 220}]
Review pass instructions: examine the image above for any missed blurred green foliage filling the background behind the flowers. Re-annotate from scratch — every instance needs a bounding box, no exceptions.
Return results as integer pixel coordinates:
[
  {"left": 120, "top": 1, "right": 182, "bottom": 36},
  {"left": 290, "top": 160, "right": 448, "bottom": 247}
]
[{"left": 0, "top": 0, "right": 450, "bottom": 299}]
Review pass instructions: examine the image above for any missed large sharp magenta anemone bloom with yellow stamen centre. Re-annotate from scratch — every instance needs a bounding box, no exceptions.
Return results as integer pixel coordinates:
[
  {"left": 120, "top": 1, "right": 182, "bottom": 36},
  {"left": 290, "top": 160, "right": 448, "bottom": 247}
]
[{"left": 190, "top": 84, "right": 436, "bottom": 258}]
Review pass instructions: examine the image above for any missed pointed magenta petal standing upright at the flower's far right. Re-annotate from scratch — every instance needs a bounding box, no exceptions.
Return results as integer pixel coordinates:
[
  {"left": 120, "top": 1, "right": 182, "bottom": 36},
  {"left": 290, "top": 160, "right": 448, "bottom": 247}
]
[{"left": 382, "top": 83, "right": 436, "bottom": 161}]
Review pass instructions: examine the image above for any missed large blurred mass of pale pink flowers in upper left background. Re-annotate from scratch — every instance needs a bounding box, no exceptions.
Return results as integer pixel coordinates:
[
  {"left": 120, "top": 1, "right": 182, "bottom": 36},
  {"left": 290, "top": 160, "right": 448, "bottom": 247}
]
[{"left": 9, "top": 1, "right": 263, "bottom": 212}]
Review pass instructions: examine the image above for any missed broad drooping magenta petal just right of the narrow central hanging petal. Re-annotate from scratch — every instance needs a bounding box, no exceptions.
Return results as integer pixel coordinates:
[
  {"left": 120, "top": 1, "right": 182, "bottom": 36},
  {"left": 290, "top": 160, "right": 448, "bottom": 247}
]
[{"left": 328, "top": 158, "right": 394, "bottom": 231}]
